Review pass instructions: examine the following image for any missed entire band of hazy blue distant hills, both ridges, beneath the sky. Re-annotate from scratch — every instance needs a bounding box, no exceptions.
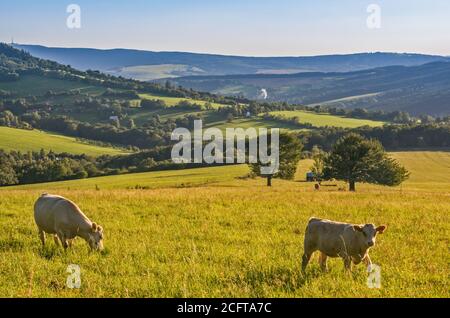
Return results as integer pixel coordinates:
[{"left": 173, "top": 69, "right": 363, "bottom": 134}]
[{"left": 4, "top": 44, "right": 450, "bottom": 116}]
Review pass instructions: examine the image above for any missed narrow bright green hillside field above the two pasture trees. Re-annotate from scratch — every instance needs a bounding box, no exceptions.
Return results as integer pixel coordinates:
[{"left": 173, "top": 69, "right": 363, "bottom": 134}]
[{"left": 270, "top": 110, "right": 385, "bottom": 128}]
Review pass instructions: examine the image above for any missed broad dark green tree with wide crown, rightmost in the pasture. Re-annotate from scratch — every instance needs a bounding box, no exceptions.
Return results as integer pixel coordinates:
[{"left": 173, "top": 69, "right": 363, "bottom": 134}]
[{"left": 324, "top": 134, "right": 409, "bottom": 191}]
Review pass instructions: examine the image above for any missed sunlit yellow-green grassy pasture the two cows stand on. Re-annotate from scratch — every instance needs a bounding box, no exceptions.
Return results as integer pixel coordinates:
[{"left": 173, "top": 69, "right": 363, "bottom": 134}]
[{"left": 0, "top": 152, "right": 450, "bottom": 297}]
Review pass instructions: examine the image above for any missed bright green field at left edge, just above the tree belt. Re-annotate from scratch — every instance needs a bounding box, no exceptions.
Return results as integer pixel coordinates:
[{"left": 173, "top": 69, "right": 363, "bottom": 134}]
[{"left": 0, "top": 127, "right": 124, "bottom": 156}]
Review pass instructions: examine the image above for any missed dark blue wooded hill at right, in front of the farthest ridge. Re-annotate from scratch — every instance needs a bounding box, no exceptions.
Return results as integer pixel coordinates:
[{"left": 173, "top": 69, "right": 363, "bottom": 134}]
[{"left": 171, "top": 62, "right": 450, "bottom": 115}]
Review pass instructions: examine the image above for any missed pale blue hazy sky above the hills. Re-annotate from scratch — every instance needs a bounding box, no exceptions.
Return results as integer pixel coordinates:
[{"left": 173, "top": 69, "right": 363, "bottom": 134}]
[{"left": 0, "top": 0, "right": 450, "bottom": 56}]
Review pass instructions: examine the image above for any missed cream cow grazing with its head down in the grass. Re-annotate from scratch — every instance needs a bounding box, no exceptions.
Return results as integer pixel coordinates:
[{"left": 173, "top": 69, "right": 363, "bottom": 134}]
[{"left": 34, "top": 194, "right": 103, "bottom": 250}]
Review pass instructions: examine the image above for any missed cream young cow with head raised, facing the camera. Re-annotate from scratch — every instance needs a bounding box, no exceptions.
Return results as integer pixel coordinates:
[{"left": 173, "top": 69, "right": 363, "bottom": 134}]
[{"left": 302, "top": 218, "right": 386, "bottom": 272}]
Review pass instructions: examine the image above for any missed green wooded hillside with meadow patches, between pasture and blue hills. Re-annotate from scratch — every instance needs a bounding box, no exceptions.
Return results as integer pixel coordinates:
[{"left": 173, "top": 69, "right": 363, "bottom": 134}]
[{"left": 0, "top": 44, "right": 450, "bottom": 185}]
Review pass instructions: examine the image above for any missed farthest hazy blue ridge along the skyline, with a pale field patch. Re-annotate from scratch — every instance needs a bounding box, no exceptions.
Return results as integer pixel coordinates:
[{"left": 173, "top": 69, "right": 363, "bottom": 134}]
[{"left": 14, "top": 44, "right": 448, "bottom": 80}]
